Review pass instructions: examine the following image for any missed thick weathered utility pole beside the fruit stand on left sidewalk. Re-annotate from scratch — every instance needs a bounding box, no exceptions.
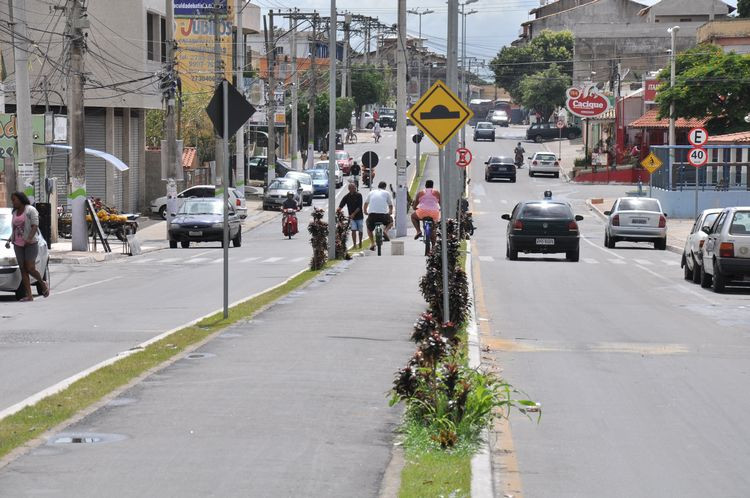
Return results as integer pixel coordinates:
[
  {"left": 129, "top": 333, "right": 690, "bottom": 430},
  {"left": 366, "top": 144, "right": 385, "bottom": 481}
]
[{"left": 67, "top": 0, "right": 89, "bottom": 251}]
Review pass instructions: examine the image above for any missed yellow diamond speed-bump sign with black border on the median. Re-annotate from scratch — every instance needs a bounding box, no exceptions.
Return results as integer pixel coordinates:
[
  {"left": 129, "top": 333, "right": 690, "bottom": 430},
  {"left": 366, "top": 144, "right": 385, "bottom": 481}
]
[{"left": 407, "top": 80, "right": 474, "bottom": 148}]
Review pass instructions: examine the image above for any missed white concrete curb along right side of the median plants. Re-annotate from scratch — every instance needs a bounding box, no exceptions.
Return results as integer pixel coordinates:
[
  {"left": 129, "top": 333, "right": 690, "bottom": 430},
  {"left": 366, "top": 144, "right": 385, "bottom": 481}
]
[{"left": 465, "top": 245, "right": 495, "bottom": 498}]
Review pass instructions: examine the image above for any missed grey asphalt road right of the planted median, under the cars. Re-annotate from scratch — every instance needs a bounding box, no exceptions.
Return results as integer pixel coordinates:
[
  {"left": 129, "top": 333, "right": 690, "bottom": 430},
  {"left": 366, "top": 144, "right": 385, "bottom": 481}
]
[{"left": 472, "top": 129, "right": 750, "bottom": 497}]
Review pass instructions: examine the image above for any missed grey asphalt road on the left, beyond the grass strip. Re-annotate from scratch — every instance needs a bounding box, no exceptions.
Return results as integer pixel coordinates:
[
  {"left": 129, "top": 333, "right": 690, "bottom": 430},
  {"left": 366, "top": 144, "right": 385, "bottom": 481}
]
[{"left": 0, "top": 128, "right": 434, "bottom": 411}]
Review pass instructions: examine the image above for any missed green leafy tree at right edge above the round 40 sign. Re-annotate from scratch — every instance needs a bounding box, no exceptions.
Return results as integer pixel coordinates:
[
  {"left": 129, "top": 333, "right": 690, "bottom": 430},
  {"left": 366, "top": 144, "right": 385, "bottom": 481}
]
[{"left": 656, "top": 45, "right": 750, "bottom": 134}]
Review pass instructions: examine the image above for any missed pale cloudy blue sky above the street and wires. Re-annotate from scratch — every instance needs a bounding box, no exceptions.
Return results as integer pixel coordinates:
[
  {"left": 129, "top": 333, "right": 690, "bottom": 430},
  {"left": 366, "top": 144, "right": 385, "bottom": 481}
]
[{"left": 252, "top": 0, "right": 737, "bottom": 78}]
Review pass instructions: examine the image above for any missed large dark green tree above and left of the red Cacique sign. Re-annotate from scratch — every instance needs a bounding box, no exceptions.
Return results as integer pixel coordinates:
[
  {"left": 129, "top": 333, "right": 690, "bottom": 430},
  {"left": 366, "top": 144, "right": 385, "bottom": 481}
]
[{"left": 490, "top": 30, "right": 573, "bottom": 102}]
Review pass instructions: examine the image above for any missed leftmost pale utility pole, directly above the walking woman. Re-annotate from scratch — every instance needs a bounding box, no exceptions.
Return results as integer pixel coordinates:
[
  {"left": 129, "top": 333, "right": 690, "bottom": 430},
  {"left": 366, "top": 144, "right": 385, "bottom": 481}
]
[{"left": 8, "top": 0, "right": 34, "bottom": 200}]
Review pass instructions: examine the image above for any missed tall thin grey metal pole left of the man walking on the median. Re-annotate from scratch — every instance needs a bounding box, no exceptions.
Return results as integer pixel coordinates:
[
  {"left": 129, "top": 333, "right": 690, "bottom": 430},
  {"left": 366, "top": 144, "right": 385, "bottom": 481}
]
[{"left": 328, "top": 0, "right": 336, "bottom": 259}]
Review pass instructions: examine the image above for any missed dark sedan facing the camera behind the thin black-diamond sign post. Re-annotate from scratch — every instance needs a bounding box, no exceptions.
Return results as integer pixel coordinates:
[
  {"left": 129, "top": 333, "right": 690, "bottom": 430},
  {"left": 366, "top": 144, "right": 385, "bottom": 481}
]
[{"left": 168, "top": 197, "right": 242, "bottom": 249}]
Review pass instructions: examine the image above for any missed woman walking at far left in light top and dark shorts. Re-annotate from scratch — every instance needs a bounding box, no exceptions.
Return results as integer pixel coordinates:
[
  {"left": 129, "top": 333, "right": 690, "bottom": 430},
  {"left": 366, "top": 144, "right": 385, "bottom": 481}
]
[{"left": 5, "top": 192, "right": 49, "bottom": 301}]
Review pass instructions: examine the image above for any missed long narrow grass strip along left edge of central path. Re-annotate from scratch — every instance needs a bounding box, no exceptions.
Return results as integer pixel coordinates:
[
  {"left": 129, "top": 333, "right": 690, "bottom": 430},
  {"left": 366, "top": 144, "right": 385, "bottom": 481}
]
[{"left": 0, "top": 262, "right": 335, "bottom": 458}]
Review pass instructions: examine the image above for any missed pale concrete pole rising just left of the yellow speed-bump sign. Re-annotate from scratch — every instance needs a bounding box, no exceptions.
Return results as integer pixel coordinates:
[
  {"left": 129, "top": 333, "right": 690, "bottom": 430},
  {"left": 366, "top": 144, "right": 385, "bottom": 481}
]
[{"left": 396, "top": 0, "right": 408, "bottom": 237}]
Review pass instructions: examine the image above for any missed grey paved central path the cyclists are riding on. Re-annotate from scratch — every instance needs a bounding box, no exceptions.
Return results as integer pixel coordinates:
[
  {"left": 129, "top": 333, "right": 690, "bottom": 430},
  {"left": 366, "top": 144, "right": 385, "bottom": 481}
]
[{"left": 0, "top": 241, "right": 432, "bottom": 497}]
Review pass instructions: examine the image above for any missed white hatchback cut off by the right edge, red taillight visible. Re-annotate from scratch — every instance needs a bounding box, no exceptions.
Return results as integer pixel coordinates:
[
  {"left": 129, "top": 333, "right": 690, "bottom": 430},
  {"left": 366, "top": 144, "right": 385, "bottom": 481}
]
[{"left": 701, "top": 206, "right": 750, "bottom": 292}]
